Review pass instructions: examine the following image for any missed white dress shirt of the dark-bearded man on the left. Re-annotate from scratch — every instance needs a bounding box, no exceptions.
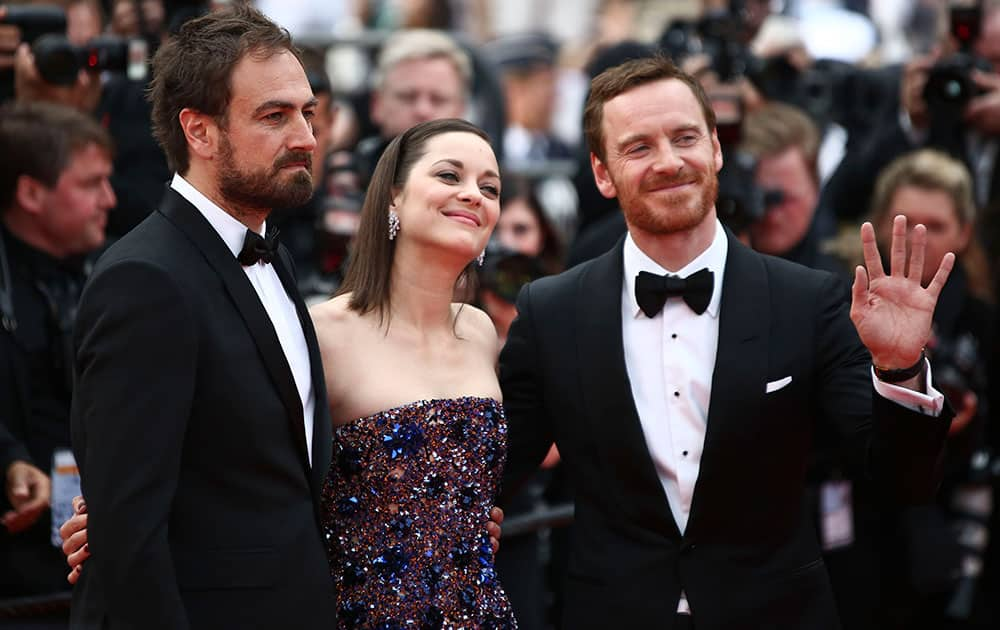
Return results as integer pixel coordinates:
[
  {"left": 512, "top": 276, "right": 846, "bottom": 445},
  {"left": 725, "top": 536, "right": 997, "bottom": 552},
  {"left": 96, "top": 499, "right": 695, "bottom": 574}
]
[{"left": 170, "top": 174, "right": 316, "bottom": 465}]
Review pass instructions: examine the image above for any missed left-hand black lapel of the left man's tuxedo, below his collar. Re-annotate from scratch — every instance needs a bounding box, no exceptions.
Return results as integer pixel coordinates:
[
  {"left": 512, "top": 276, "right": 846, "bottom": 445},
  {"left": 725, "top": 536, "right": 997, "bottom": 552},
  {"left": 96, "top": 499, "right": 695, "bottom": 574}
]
[{"left": 160, "top": 189, "right": 309, "bottom": 474}]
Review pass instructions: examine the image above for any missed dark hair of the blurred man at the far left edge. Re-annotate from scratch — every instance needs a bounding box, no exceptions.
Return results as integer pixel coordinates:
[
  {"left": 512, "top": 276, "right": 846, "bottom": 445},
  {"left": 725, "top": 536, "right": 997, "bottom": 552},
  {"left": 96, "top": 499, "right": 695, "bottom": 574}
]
[{"left": 0, "top": 102, "right": 113, "bottom": 210}]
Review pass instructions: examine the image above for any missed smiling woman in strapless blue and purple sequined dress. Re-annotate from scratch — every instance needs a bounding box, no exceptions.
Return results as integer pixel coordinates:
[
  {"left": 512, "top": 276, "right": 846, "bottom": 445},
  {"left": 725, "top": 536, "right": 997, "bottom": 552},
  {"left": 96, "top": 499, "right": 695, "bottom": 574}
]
[{"left": 312, "top": 120, "right": 517, "bottom": 629}]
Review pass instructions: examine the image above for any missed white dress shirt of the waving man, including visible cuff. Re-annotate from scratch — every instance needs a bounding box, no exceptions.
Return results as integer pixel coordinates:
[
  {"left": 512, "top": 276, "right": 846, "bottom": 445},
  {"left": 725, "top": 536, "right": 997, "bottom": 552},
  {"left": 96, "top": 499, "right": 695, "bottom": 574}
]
[{"left": 621, "top": 220, "right": 944, "bottom": 613}]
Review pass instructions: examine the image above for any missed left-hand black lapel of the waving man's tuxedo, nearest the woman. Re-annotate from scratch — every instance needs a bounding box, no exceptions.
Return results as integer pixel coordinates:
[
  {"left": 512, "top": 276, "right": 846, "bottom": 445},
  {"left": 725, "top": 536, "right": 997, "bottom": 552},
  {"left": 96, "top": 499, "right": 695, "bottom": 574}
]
[{"left": 575, "top": 239, "right": 680, "bottom": 539}]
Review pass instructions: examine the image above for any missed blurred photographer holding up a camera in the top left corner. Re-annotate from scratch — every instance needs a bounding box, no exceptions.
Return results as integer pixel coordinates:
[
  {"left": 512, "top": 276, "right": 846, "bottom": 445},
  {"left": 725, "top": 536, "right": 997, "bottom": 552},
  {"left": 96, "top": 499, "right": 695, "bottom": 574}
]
[{"left": 0, "top": 0, "right": 182, "bottom": 238}]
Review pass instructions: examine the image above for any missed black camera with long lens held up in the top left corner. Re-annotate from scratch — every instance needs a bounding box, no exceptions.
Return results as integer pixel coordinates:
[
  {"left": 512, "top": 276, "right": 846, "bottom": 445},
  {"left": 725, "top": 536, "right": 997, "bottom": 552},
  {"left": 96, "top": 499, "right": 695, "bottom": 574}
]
[{"left": 31, "top": 33, "right": 146, "bottom": 85}]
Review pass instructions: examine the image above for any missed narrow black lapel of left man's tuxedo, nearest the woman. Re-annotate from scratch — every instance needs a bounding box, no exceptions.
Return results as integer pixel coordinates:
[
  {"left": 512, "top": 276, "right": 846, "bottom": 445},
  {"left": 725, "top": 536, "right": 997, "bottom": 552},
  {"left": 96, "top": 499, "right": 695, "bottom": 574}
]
[{"left": 272, "top": 247, "right": 333, "bottom": 505}]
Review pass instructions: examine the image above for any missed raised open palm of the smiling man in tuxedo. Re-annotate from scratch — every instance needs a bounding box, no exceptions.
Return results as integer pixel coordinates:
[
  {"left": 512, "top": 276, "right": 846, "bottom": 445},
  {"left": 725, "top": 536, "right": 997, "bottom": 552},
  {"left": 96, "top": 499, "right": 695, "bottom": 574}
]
[{"left": 851, "top": 215, "right": 955, "bottom": 369}]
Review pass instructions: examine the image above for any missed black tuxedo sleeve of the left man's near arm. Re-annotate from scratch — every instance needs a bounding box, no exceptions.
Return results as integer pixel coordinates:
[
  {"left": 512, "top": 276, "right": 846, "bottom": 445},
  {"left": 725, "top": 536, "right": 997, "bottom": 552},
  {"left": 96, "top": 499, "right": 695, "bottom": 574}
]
[{"left": 72, "top": 261, "right": 195, "bottom": 630}]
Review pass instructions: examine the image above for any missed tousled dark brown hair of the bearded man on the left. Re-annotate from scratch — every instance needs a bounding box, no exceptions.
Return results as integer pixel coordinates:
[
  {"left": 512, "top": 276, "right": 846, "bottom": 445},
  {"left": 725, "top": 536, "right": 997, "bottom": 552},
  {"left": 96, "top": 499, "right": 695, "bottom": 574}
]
[{"left": 148, "top": 2, "right": 301, "bottom": 175}]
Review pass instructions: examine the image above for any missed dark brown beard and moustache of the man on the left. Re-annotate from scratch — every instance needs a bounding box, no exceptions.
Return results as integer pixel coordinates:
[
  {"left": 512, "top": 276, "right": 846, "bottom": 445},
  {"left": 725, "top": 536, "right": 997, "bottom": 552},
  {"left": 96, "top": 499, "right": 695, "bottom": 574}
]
[{"left": 219, "top": 134, "right": 313, "bottom": 210}]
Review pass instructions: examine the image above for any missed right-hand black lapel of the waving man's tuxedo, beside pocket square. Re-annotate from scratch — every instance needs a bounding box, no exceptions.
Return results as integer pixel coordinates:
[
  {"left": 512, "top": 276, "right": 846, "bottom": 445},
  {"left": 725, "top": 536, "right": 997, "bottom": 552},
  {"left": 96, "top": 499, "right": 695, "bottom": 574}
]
[{"left": 687, "top": 230, "right": 771, "bottom": 532}]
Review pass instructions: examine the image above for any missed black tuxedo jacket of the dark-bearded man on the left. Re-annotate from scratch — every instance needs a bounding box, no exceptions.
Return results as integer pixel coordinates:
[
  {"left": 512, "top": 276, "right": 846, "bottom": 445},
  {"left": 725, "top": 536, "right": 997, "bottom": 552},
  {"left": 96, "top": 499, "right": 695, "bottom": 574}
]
[{"left": 72, "top": 190, "right": 335, "bottom": 630}]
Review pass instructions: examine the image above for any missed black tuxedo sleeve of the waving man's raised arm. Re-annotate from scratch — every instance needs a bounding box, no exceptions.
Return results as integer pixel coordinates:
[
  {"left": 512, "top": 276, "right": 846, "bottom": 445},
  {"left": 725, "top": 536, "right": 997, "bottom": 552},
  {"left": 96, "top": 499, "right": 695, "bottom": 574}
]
[{"left": 816, "top": 278, "right": 952, "bottom": 505}]
